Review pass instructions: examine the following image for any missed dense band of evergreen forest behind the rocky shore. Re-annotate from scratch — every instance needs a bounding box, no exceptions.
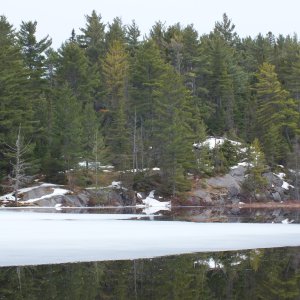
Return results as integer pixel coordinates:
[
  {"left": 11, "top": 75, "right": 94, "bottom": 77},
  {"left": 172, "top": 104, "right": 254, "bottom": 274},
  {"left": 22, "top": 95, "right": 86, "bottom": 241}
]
[{"left": 0, "top": 11, "right": 300, "bottom": 194}]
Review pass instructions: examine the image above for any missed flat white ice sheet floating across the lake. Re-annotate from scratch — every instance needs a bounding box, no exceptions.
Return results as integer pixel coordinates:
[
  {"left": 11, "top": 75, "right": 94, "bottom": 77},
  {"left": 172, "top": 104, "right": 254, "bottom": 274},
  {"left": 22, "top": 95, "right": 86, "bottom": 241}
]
[{"left": 0, "top": 211, "right": 300, "bottom": 266}]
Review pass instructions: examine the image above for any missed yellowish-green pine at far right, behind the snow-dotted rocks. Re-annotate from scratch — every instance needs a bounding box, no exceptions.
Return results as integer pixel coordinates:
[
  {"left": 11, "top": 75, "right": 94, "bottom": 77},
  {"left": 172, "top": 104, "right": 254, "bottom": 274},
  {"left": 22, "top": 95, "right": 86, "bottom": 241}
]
[{"left": 255, "top": 63, "right": 299, "bottom": 164}]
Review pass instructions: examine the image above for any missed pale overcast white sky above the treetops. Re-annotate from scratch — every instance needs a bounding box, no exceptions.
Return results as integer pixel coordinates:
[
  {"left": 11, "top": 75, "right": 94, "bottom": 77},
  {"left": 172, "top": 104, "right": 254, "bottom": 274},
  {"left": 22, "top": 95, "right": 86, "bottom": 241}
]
[{"left": 0, "top": 0, "right": 300, "bottom": 48}]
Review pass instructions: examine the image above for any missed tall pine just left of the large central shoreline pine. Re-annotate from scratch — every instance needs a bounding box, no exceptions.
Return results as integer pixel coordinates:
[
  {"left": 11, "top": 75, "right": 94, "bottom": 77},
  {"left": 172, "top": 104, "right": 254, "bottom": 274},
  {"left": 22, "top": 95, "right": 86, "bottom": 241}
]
[{"left": 128, "top": 41, "right": 169, "bottom": 169}]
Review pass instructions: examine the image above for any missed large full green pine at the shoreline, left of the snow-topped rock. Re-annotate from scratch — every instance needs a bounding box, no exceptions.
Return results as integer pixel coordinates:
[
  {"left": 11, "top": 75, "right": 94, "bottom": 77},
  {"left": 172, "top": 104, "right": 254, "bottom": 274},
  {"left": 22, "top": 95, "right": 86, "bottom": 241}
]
[{"left": 151, "top": 68, "right": 193, "bottom": 195}]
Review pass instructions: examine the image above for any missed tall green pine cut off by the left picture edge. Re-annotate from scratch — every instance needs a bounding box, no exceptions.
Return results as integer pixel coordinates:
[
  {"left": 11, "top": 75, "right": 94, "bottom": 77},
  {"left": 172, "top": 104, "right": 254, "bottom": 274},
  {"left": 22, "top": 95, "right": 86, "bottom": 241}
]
[{"left": 0, "top": 16, "right": 35, "bottom": 179}]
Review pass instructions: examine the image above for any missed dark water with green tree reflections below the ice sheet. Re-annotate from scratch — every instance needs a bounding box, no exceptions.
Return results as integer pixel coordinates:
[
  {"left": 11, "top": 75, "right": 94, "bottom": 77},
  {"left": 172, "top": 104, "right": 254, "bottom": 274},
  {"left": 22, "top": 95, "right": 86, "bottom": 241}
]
[{"left": 0, "top": 247, "right": 300, "bottom": 300}]
